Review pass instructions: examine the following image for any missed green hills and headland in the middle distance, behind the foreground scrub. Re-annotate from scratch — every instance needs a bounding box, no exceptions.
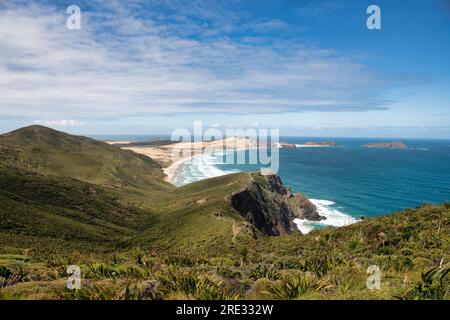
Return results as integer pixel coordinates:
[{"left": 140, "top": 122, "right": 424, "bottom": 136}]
[{"left": 0, "top": 126, "right": 324, "bottom": 251}]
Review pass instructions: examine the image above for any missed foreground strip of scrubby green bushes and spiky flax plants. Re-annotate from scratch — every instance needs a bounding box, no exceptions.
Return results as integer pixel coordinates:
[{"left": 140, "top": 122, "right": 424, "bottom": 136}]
[{"left": 0, "top": 204, "right": 450, "bottom": 299}]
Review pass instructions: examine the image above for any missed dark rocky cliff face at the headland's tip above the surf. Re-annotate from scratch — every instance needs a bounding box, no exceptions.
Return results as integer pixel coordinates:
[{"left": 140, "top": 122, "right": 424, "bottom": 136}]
[{"left": 230, "top": 173, "right": 324, "bottom": 236}]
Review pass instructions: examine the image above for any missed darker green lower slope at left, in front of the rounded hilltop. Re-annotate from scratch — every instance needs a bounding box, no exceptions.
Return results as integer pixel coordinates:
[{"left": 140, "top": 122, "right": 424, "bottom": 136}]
[{"left": 0, "top": 166, "right": 157, "bottom": 248}]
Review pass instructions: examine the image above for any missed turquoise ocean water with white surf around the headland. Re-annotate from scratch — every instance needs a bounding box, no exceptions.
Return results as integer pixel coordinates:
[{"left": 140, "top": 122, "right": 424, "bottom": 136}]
[{"left": 169, "top": 137, "right": 450, "bottom": 233}]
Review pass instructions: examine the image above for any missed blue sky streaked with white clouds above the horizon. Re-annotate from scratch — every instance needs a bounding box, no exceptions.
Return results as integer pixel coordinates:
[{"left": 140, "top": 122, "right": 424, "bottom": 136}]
[{"left": 0, "top": 0, "right": 450, "bottom": 138}]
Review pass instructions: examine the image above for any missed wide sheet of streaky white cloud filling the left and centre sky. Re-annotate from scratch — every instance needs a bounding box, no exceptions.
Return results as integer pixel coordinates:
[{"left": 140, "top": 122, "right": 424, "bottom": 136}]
[{"left": 0, "top": 1, "right": 412, "bottom": 121}]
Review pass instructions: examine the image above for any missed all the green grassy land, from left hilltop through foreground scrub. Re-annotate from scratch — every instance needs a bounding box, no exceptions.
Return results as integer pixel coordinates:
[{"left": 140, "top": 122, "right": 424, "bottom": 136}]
[{"left": 0, "top": 126, "right": 450, "bottom": 299}]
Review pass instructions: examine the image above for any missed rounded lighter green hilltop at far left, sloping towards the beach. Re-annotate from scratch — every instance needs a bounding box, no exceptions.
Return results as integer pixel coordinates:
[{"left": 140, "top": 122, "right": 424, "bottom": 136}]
[{"left": 0, "top": 125, "right": 172, "bottom": 191}]
